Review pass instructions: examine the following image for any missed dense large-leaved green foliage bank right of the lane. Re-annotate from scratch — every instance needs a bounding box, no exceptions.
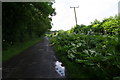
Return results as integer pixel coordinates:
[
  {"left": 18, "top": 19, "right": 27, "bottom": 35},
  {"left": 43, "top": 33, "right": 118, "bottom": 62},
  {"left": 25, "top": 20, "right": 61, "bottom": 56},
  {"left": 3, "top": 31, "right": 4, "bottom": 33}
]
[{"left": 48, "top": 16, "right": 120, "bottom": 80}]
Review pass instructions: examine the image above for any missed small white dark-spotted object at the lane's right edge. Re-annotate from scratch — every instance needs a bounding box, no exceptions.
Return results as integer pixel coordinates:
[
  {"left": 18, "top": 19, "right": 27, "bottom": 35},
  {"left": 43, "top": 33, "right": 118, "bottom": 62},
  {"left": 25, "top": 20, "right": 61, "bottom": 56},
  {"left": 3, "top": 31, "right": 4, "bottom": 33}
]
[{"left": 55, "top": 61, "right": 65, "bottom": 76}]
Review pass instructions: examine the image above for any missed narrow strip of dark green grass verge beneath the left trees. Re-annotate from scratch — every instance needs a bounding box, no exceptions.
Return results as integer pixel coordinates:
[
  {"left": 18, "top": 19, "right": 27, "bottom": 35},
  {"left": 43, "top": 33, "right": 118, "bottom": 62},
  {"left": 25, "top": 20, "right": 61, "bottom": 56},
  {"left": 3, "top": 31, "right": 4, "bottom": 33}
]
[{"left": 2, "top": 38, "right": 42, "bottom": 62}]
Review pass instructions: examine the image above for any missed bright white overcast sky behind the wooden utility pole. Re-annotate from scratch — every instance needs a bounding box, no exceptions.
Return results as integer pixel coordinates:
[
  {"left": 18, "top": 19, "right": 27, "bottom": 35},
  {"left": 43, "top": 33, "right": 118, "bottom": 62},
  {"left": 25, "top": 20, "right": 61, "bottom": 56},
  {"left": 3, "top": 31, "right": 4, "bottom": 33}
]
[{"left": 51, "top": 0, "right": 120, "bottom": 30}]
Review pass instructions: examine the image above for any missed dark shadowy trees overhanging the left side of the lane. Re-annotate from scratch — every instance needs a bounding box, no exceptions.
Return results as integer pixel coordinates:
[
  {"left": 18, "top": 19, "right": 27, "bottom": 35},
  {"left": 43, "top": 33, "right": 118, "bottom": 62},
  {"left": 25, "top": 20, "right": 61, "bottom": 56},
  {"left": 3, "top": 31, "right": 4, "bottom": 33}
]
[{"left": 2, "top": 2, "right": 56, "bottom": 50}]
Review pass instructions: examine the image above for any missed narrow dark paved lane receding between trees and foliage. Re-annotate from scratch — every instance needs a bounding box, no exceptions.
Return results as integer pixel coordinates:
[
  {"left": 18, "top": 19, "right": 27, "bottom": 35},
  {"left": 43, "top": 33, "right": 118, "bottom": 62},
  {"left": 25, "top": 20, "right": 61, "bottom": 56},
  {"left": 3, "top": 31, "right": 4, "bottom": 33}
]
[{"left": 2, "top": 37, "right": 62, "bottom": 79}]
